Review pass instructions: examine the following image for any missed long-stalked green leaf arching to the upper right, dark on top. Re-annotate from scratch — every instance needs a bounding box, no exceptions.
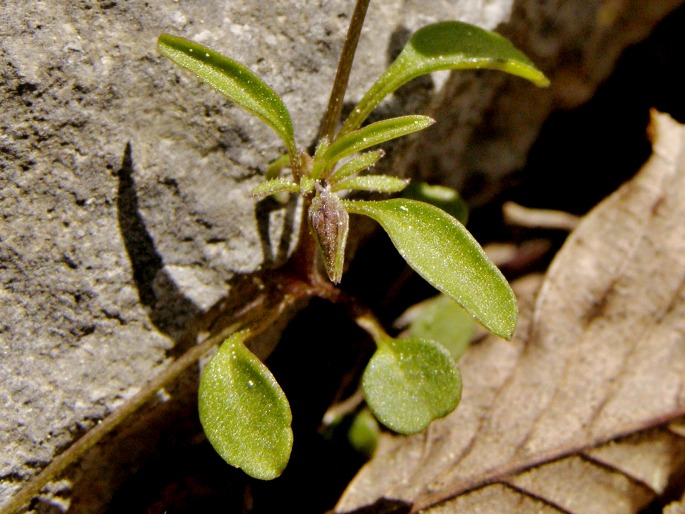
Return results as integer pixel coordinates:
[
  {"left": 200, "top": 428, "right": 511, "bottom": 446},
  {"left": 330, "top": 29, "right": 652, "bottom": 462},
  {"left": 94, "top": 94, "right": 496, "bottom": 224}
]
[{"left": 341, "top": 21, "right": 549, "bottom": 134}]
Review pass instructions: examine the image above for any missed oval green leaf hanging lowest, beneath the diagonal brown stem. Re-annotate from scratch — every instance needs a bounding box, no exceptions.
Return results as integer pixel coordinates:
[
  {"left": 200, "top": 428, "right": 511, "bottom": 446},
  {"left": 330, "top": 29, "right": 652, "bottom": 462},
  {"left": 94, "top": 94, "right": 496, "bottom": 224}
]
[{"left": 198, "top": 331, "right": 293, "bottom": 480}]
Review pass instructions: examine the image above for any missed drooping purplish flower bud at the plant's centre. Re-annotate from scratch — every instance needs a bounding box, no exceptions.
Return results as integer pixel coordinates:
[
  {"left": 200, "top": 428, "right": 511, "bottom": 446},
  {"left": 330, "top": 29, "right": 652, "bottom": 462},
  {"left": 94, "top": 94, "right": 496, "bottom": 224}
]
[{"left": 309, "top": 183, "right": 350, "bottom": 284}]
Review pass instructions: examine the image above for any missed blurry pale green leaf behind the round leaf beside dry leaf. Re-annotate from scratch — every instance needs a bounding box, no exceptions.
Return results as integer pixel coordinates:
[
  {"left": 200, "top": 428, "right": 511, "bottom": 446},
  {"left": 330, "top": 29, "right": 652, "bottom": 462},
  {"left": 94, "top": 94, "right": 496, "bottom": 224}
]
[{"left": 398, "top": 294, "right": 476, "bottom": 361}]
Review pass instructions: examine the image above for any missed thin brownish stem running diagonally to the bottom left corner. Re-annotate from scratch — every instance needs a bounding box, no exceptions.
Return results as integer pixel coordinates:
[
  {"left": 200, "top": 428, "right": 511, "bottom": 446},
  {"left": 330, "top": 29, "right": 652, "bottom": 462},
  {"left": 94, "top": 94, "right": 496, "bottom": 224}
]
[{"left": 2, "top": 290, "right": 308, "bottom": 514}]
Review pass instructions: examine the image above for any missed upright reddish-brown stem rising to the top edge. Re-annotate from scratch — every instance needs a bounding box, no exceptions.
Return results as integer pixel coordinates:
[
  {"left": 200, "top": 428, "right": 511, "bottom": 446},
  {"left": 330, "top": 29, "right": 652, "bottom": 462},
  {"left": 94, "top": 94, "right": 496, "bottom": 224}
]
[{"left": 319, "top": 0, "right": 371, "bottom": 141}]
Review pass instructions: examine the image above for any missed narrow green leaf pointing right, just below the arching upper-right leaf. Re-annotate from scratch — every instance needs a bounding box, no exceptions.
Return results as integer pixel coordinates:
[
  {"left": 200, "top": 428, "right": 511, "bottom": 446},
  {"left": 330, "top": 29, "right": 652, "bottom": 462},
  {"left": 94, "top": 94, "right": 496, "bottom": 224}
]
[{"left": 314, "top": 115, "right": 435, "bottom": 173}]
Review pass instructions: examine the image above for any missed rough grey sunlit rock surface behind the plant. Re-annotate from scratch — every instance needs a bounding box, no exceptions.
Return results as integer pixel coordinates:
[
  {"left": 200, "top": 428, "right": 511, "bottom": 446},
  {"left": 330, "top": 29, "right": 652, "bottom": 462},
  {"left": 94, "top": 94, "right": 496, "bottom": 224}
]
[{"left": 0, "top": 0, "right": 510, "bottom": 512}]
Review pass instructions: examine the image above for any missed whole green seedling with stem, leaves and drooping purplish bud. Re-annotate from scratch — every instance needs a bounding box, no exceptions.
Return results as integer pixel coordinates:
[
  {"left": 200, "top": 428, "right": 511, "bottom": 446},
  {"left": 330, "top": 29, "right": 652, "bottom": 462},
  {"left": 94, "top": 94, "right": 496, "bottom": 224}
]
[{"left": 158, "top": 1, "right": 548, "bottom": 479}]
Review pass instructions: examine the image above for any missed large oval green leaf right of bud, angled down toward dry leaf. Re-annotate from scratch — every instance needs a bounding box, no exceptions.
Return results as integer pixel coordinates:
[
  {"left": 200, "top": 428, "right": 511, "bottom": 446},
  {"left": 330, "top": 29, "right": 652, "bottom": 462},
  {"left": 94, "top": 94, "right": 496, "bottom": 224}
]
[{"left": 345, "top": 198, "right": 518, "bottom": 339}]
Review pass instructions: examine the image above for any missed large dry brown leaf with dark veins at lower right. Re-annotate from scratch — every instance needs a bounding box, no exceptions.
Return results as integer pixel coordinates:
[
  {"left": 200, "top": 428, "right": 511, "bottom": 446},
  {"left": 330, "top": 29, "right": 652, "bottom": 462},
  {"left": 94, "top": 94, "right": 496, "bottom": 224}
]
[{"left": 336, "top": 110, "right": 685, "bottom": 514}]
